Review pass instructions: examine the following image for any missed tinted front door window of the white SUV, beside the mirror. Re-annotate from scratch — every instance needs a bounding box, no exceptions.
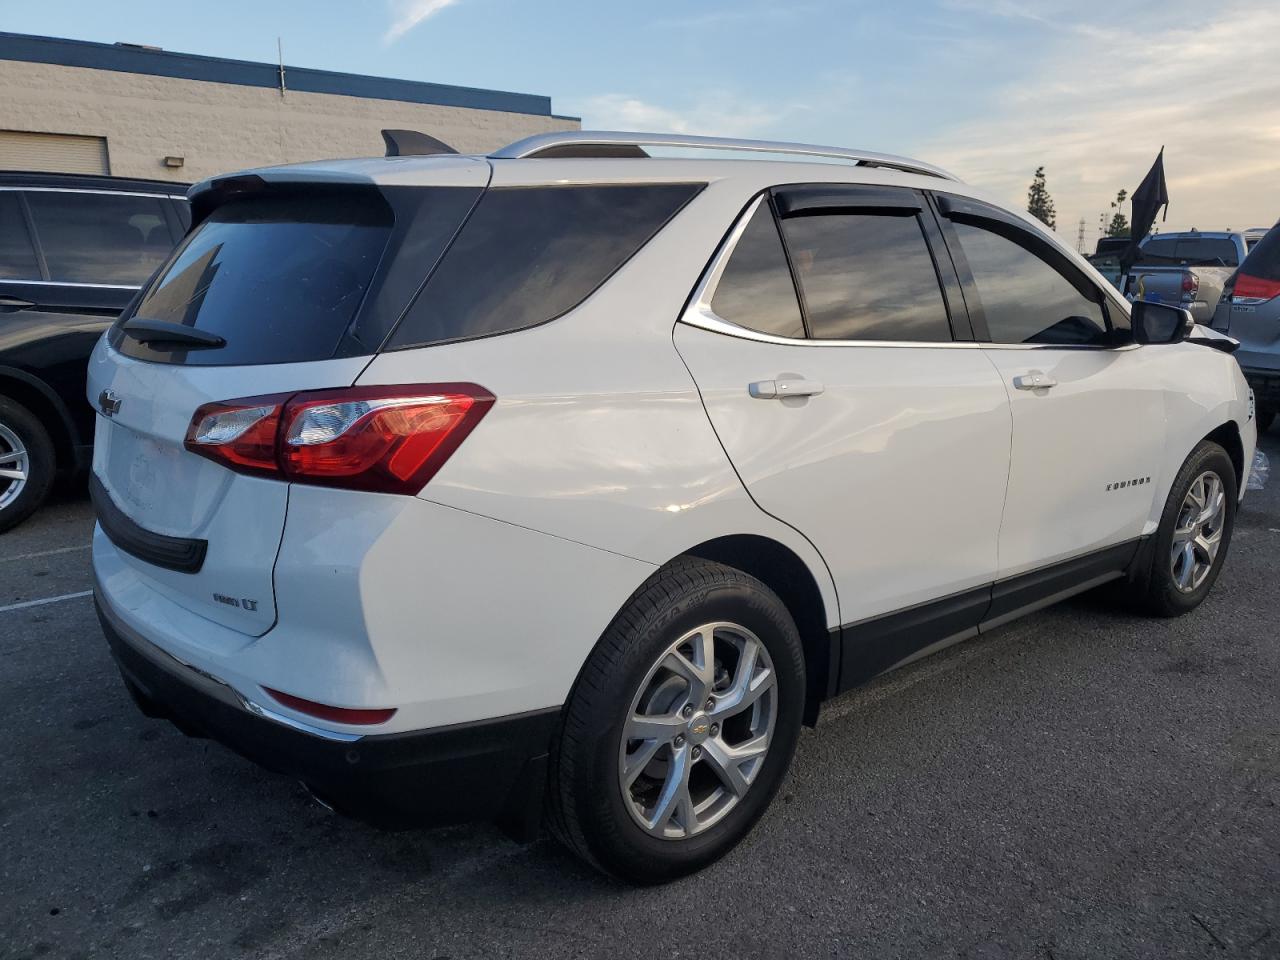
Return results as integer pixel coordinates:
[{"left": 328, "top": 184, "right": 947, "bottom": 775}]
[{"left": 955, "top": 223, "right": 1107, "bottom": 344}]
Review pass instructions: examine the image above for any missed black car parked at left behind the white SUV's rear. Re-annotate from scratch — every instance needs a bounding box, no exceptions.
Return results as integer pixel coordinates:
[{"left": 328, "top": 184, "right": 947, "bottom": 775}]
[{"left": 0, "top": 173, "right": 191, "bottom": 532}]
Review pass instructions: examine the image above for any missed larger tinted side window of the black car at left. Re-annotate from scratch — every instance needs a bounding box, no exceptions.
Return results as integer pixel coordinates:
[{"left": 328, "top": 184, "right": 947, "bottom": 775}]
[{"left": 27, "top": 191, "right": 174, "bottom": 285}]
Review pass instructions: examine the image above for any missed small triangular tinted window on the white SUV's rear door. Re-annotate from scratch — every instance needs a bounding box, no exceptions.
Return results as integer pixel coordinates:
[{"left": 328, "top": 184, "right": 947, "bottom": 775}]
[{"left": 712, "top": 202, "right": 804, "bottom": 337}]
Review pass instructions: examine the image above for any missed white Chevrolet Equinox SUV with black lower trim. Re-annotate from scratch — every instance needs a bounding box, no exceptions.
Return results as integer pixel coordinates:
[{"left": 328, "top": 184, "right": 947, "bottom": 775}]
[{"left": 88, "top": 133, "right": 1256, "bottom": 882}]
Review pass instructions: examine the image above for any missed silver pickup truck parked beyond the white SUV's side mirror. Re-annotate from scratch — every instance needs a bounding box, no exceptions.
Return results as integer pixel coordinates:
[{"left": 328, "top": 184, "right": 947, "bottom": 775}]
[{"left": 1120, "top": 230, "right": 1265, "bottom": 324}]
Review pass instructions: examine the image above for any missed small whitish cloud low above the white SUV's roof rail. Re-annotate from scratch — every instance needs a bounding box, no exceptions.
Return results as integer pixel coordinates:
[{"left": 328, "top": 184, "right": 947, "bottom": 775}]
[{"left": 566, "top": 93, "right": 808, "bottom": 137}]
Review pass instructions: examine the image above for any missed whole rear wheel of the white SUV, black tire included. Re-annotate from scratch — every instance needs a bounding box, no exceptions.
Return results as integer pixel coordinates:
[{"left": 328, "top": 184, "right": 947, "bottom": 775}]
[{"left": 549, "top": 558, "right": 805, "bottom": 883}]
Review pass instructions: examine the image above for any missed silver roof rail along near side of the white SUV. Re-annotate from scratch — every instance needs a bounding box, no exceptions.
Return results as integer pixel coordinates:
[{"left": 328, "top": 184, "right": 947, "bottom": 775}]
[{"left": 489, "top": 131, "right": 959, "bottom": 180}]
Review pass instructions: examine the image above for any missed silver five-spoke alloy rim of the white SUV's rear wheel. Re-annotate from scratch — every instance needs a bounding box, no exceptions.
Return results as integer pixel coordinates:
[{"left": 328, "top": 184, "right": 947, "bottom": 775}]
[{"left": 618, "top": 622, "right": 778, "bottom": 840}]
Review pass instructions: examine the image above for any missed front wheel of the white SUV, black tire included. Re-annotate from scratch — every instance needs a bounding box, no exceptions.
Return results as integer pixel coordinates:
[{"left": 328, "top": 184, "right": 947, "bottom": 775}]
[{"left": 1128, "top": 440, "right": 1239, "bottom": 617}]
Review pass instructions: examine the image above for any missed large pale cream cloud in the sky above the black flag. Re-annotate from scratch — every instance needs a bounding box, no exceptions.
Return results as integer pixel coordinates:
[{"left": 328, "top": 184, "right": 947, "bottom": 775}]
[{"left": 918, "top": 0, "right": 1280, "bottom": 239}]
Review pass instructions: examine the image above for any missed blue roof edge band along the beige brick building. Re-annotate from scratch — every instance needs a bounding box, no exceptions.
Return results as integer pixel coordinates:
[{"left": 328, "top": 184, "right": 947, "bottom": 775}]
[{"left": 0, "top": 31, "right": 560, "bottom": 119}]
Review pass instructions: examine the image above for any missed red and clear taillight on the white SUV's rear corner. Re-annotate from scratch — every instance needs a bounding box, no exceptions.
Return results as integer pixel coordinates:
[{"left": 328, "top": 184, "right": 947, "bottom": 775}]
[{"left": 186, "top": 383, "right": 494, "bottom": 494}]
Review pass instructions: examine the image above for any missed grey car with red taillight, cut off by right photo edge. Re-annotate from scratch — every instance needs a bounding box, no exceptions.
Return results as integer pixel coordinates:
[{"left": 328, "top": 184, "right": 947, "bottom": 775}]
[{"left": 1213, "top": 223, "right": 1280, "bottom": 431}]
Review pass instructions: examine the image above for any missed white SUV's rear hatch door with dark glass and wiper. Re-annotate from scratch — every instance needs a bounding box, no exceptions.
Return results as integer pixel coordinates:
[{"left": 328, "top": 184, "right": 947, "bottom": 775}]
[{"left": 88, "top": 157, "right": 489, "bottom": 636}]
